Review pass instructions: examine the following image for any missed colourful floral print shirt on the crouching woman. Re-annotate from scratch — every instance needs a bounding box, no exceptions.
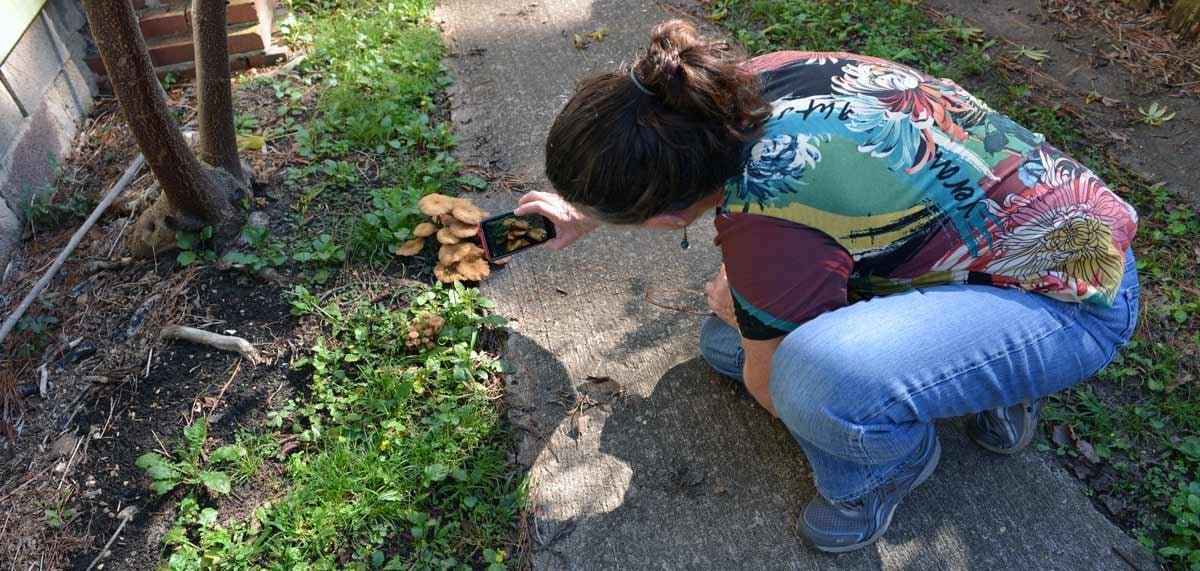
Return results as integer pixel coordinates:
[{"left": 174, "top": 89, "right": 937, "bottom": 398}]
[{"left": 716, "top": 52, "right": 1138, "bottom": 339}]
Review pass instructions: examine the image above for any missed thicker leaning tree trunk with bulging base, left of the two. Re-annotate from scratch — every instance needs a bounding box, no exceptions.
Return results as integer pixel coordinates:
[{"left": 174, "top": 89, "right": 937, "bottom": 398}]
[{"left": 83, "top": 0, "right": 250, "bottom": 258}]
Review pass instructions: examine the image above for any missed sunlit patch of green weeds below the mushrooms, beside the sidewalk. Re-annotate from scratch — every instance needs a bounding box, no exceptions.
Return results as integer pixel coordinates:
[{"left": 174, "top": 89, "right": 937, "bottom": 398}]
[{"left": 139, "top": 286, "right": 524, "bottom": 570}]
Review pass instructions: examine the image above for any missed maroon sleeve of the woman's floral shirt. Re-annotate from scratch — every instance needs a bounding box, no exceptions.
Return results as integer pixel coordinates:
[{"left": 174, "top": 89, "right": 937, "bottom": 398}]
[{"left": 716, "top": 214, "right": 854, "bottom": 339}]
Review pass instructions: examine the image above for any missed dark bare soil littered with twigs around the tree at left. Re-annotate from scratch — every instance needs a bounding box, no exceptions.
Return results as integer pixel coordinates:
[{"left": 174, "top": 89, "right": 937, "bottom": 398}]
[{"left": 0, "top": 72, "right": 314, "bottom": 569}]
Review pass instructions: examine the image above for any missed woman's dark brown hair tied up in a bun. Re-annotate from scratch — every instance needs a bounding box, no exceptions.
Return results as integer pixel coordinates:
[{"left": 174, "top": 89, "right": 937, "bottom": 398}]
[{"left": 546, "top": 20, "right": 769, "bottom": 224}]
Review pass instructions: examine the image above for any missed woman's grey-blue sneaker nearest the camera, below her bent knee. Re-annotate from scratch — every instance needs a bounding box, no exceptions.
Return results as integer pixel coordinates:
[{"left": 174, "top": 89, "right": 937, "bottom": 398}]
[{"left": 799, "top": 425, "right": 942, "bottom": 553}]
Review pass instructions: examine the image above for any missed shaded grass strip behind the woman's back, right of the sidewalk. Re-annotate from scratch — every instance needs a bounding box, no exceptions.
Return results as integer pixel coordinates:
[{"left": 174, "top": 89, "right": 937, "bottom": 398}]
[{"left": 710, "top": 0, "right": 1200, "bottom": 569}]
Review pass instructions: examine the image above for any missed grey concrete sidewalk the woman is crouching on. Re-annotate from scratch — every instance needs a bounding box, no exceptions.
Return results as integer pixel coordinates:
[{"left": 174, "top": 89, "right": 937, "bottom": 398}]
[{"left": 438, "top": 0, "right": 1152, "bottom": 571}]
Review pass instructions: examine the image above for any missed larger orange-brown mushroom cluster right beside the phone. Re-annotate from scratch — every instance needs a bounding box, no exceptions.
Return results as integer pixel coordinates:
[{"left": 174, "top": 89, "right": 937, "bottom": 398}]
[{"left": 396, "top": 194, "right": 492, "bottom": 283}]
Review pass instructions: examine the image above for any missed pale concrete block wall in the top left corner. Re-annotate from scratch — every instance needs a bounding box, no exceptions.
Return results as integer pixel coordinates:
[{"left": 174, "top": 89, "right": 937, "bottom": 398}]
[{"left": 0, "top": 0, "right": 96, "bottom": 263}]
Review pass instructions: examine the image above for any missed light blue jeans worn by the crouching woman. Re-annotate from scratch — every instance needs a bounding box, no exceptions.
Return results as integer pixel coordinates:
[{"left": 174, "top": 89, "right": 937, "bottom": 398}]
[{"left": 700, "top": 253, "right": 1139, "bottom": 501}]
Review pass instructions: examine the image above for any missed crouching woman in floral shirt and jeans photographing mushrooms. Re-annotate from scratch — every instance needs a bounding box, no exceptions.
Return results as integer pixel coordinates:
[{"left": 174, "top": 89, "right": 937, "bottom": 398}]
[{"left": 517, "top": 22, "right": 1139, "bottom": 552}]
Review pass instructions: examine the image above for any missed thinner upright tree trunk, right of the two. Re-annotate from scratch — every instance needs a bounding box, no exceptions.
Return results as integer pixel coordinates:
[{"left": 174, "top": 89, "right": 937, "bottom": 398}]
[{"left": 192, "top": 0, "right": 244, "bottom": 179}]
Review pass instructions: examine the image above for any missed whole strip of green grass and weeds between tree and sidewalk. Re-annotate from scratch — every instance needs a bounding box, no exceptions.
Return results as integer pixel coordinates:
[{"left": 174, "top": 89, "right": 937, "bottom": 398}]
[{"left": 129, "top": 0, "right": 526, "bottom": 570}]
